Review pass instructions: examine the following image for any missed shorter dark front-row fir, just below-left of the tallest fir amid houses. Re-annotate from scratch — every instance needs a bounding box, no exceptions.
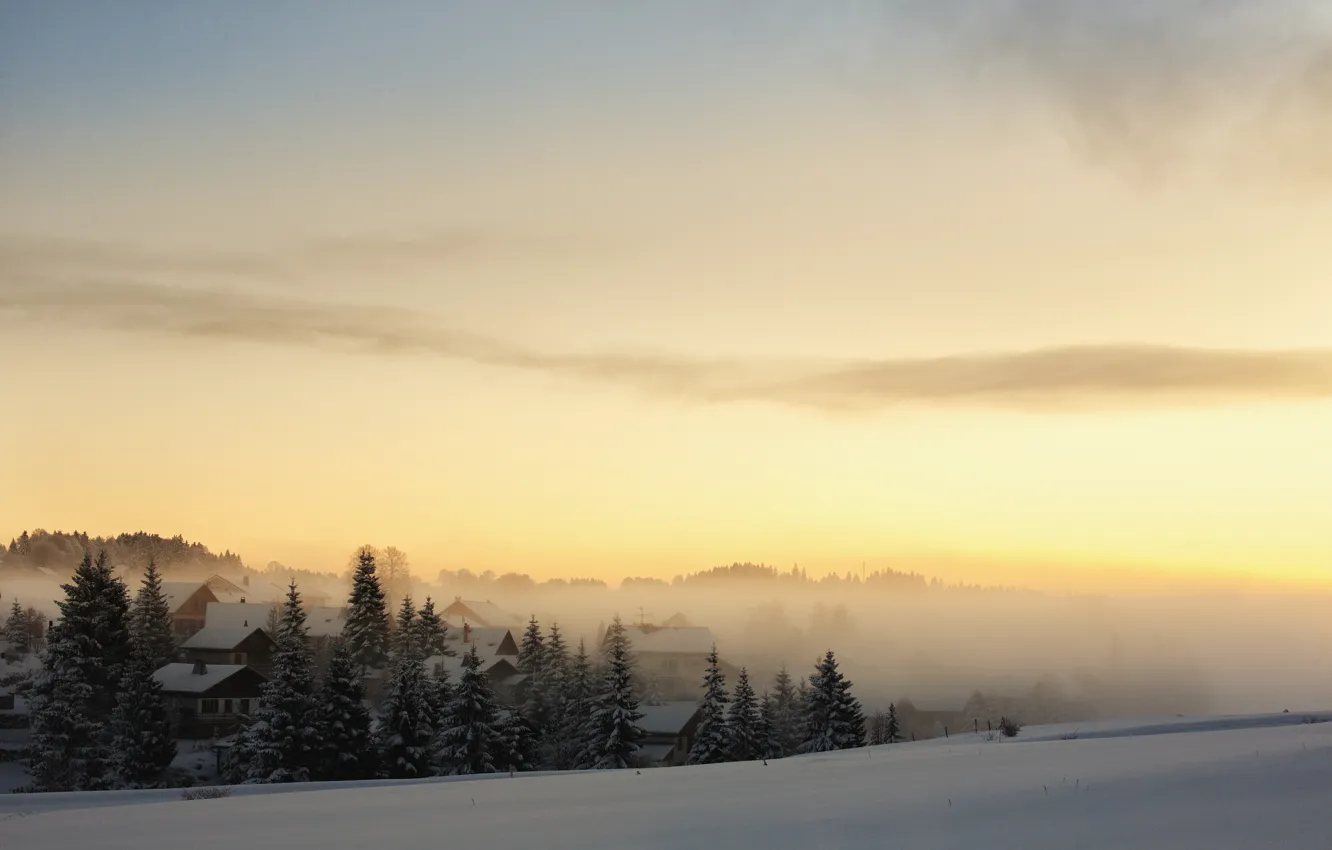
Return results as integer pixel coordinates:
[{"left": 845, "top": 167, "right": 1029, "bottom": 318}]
[{"left": 313, "top": 641, "right": 378, "bottom": 782}]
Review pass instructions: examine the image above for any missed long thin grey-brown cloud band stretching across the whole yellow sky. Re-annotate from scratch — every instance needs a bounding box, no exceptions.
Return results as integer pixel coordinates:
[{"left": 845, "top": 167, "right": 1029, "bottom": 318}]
[{"left": 0, "top": 280, "right": 1332, "bottom": 412}]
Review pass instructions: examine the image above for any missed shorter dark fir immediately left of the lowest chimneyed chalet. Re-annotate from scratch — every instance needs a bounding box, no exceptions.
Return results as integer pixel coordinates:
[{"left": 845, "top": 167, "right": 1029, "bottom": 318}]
[{"left": 111, "top": 652, "right": 176, "bottom": 789}]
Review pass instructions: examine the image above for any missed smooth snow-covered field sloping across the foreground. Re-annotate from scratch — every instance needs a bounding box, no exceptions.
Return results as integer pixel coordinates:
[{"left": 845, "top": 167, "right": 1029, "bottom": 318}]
[{"left": 0, "top": 714, "right": 1332, "bottom": 850}]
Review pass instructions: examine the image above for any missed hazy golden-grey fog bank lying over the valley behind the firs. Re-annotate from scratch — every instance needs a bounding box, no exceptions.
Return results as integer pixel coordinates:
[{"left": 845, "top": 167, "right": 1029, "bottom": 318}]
[{"left": 0, "top": 565, "right": 1332, "bottom": 722}]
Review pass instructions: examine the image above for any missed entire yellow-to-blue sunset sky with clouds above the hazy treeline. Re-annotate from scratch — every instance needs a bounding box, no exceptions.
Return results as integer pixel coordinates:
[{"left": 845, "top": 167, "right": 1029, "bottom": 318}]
[{"left": 0, "top": 0, "right": 1332, "bottom": 589}]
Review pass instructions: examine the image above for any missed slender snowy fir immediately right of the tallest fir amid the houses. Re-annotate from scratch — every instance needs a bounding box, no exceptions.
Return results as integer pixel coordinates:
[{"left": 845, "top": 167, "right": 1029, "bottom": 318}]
[{"left": 377, "top": 596, "right": 437, "bottom": 779}]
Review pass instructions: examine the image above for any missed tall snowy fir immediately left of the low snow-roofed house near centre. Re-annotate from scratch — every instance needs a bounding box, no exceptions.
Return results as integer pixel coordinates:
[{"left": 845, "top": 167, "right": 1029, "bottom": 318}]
[{"left": 587, "top": 616, "right": 645, "bottom": 770}]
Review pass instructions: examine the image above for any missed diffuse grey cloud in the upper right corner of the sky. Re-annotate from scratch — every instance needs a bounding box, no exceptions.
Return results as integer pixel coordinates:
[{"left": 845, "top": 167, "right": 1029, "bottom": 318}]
[{"left": 864, "top": 0, "right": 1332, "bottom": 187}]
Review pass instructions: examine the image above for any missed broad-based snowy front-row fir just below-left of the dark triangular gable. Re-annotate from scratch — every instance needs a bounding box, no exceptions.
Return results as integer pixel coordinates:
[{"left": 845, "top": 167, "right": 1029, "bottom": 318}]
[{"left": 436, "top": 643, "right": 509, "bottom": 775}]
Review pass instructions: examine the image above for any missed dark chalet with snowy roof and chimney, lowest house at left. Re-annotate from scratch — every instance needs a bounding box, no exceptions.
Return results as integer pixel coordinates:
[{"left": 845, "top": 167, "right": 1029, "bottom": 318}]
[{"left": 153, "top": 661, "right": 268, "bottom": 738}]
